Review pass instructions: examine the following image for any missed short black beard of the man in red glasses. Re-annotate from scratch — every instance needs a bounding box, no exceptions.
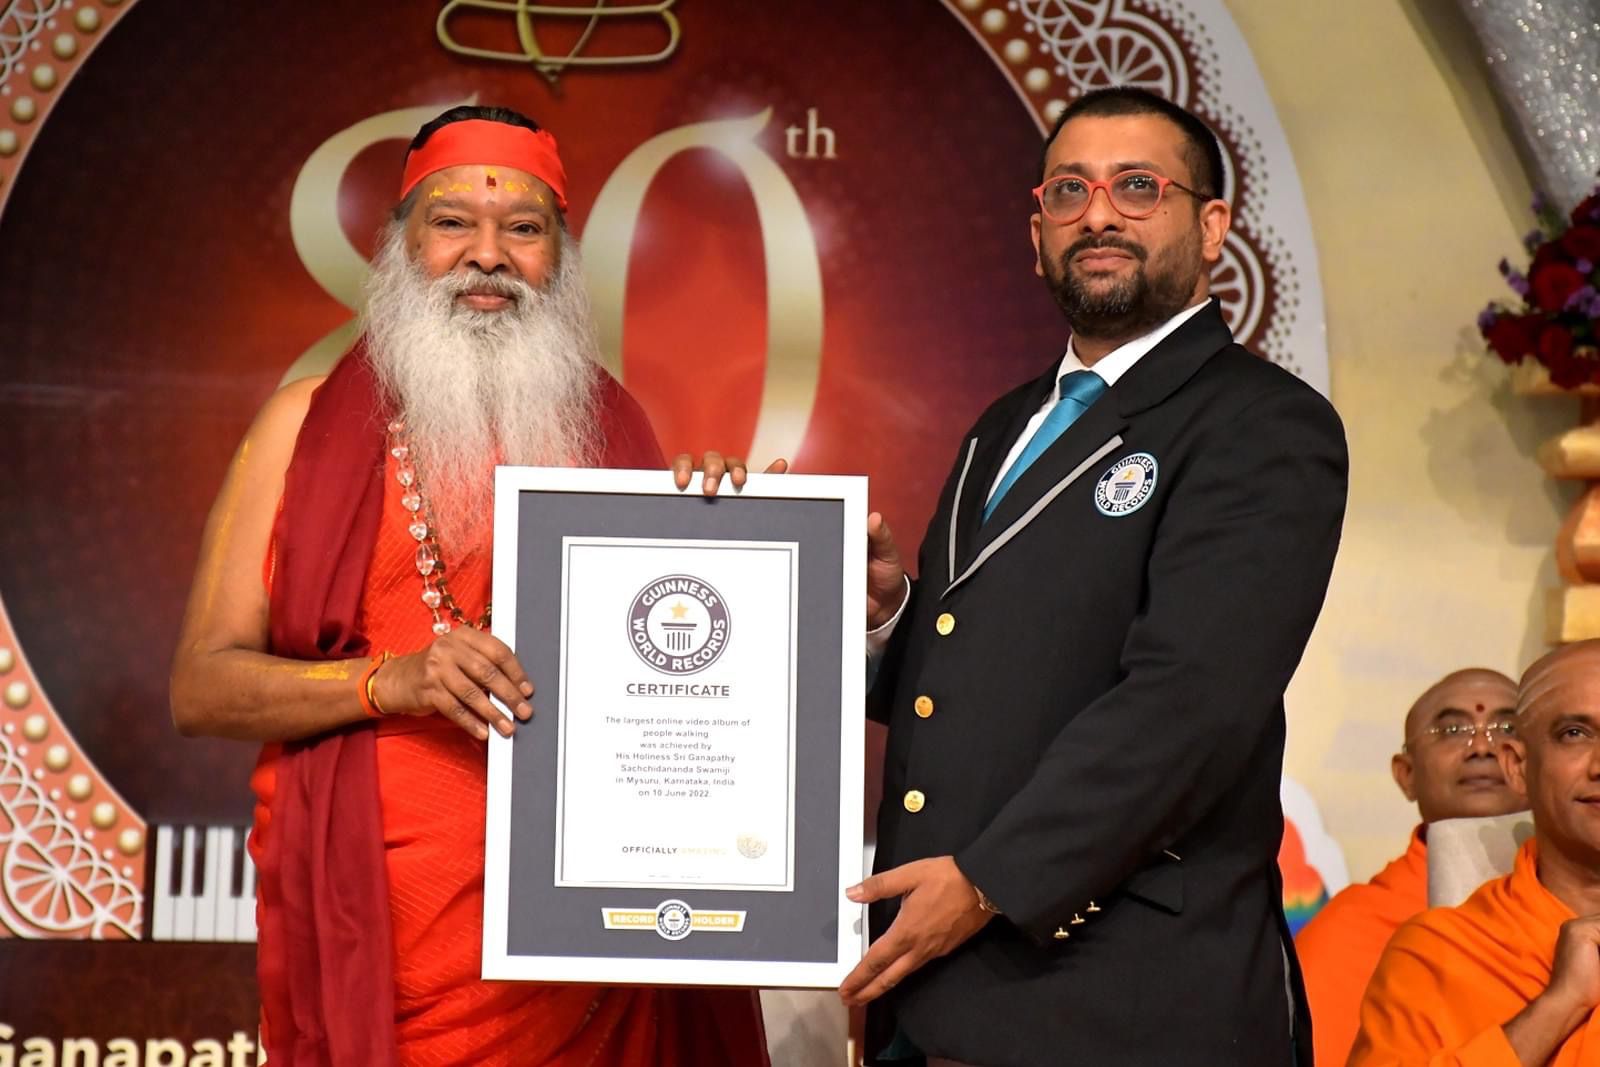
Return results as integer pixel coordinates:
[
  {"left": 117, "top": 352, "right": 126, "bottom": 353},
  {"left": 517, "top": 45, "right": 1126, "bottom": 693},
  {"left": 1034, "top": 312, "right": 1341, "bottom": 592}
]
[{"left": 1045, "top": 237, "right": 1200, "bottom": 341}]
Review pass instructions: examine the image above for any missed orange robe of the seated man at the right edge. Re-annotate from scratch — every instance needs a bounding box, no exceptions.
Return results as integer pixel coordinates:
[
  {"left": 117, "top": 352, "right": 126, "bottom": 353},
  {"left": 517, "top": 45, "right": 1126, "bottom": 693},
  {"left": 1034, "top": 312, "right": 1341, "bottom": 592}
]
[{"left": 1349, "top": 841, "right": 1600, "bottom": 1067}]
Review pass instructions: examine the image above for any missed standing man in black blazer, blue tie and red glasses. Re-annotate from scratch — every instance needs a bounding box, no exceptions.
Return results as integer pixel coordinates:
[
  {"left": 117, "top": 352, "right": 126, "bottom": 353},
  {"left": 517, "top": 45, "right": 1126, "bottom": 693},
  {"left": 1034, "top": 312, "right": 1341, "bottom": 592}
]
[{"left": 840, "top": 90, "right": 1347, "bottom": 1067}]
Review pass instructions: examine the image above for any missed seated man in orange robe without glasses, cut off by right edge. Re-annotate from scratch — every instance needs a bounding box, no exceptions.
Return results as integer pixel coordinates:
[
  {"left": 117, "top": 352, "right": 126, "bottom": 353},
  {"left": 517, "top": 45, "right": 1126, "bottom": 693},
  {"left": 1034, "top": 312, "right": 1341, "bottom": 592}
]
[{"left": 1349, "top": 641, "right": 1600, "bottom": 1067}]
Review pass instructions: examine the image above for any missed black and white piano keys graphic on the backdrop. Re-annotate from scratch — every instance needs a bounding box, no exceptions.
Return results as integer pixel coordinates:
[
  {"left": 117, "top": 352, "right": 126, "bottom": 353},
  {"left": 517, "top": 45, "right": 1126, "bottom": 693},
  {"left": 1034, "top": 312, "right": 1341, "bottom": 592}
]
[{"left": 150, "top": 825, "right": 256, "bottom": 941}]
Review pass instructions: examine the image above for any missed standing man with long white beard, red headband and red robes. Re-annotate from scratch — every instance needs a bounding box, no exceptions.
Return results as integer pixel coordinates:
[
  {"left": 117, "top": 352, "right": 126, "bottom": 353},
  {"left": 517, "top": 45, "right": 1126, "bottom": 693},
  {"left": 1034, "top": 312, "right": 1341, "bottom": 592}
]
[{"left": 171, "top": 107, "right": 766, "bottom": 1067}]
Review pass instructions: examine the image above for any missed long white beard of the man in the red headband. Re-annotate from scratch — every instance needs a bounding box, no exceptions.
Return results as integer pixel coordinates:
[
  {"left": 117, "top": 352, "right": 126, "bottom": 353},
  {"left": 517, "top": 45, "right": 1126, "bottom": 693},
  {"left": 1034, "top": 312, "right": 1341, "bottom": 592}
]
[{"left": 363, "top": 224, "right": 602, "bottom": 558}]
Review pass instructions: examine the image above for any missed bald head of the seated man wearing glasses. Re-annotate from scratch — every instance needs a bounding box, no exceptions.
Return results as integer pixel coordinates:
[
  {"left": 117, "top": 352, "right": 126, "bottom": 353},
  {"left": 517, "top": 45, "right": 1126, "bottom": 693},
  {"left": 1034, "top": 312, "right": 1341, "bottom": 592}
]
[{"left": 1390, "top": 667, "right": 1526, "bottom": 822}]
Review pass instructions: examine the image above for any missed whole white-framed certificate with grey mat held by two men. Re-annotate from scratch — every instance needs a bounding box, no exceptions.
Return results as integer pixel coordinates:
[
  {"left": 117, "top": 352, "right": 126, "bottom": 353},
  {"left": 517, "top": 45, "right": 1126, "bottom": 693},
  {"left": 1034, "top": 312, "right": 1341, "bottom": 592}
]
[{"left": 483, "top": 467, "right": 867, "bottom": 987}]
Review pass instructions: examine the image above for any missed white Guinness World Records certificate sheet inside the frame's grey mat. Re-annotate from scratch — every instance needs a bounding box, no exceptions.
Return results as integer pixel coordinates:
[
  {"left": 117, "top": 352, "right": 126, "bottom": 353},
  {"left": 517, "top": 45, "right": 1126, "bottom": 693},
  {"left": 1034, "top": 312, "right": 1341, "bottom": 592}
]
[{"left": 555, "top": 537, "right": 800, "bottom": 891}]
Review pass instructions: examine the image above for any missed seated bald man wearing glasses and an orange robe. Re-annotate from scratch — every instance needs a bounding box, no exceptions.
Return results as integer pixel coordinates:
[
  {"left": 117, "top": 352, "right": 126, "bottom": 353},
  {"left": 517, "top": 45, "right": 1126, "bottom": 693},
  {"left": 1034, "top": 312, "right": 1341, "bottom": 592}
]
[{"left": 1294, "top": 669, "right": 1528, "bottom": 1064}]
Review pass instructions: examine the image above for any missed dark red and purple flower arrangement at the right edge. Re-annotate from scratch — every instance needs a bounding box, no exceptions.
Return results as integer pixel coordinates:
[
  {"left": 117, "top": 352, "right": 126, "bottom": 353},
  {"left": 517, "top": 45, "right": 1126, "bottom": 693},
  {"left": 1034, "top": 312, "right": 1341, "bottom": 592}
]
[{"left": 1478, "top": 187, "right": 1600, "bottom": 389}]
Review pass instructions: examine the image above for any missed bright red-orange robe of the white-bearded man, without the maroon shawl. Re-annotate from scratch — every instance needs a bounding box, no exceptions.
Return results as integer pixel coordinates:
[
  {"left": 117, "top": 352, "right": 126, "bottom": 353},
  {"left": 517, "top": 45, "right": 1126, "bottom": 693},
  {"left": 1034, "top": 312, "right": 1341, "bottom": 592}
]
[{"left": 250, "top": 456, "right": 766, "bottom": 1067}]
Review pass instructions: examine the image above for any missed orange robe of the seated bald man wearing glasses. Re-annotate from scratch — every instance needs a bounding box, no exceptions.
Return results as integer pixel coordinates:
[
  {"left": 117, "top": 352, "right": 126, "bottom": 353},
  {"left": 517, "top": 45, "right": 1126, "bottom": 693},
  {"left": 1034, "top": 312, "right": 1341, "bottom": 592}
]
[{"left": 1294, "top": 827, "right": 1427, "bottom": 1067}]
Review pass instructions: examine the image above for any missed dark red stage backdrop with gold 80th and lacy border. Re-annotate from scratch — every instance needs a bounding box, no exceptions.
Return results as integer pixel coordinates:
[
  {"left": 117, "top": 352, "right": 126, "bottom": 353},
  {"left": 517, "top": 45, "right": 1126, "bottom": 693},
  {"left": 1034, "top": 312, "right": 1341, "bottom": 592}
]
[{"left": 0, "top": 0, "right": 1324, "bottom": 1048}]
